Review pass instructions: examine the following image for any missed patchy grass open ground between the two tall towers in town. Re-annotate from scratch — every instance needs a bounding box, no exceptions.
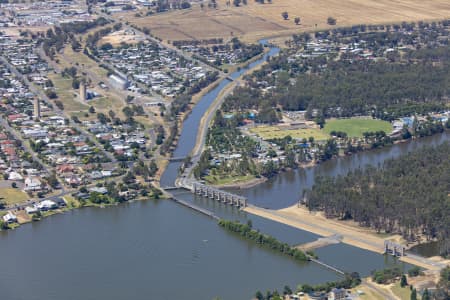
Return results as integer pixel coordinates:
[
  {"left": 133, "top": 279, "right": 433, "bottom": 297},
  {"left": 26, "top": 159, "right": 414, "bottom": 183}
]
[{"left": 48, "top": 74, "right": 89, "bottom": 111}]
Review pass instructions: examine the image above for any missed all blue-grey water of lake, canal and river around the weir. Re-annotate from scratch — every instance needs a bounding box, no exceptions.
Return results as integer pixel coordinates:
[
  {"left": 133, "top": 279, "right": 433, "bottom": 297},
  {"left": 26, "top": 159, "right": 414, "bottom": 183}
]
[{"left": 0, "top": 40, "right": 449, "bottom": 300}]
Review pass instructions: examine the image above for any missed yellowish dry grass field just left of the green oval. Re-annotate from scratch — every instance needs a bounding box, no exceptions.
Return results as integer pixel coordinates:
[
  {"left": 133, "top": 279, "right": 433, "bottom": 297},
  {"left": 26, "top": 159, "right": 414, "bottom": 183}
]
[{"left": 250, "top": 126, "right": 329, "bottom": 141}]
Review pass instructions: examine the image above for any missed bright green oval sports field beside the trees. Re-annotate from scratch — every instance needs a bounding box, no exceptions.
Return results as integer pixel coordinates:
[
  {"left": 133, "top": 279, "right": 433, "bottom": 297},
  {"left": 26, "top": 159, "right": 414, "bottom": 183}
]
[{"left": 324, "top": 118, "right": 392, "bottom": 137}]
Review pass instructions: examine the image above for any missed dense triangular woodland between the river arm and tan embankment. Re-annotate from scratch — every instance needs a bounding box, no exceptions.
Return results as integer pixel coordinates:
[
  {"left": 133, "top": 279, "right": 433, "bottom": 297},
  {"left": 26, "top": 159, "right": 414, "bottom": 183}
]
[{"left": 307, "top": 143, "right": 450, "bottom": 254}]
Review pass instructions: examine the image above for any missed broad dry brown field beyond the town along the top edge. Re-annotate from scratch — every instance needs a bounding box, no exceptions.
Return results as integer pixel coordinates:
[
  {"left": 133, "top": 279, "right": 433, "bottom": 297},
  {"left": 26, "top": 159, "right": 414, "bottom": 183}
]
[{"left": 122, "top": 0, "right": 450, "bottom": 41}]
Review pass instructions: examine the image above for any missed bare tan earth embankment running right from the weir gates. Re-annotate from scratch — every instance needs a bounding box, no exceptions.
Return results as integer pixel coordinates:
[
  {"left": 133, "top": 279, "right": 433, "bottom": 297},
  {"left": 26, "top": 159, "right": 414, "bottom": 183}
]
[{"left": 244, "top": 205, "right": 450, "bottom": 270}]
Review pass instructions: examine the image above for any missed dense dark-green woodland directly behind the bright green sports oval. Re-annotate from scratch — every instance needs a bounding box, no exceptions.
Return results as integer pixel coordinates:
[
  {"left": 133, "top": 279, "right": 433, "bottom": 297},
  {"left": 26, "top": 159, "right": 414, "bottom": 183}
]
[{"left": 275, "top": 59, "right": 450, "bottom": 120}]
